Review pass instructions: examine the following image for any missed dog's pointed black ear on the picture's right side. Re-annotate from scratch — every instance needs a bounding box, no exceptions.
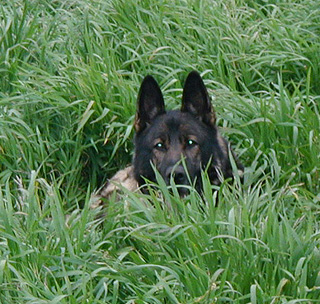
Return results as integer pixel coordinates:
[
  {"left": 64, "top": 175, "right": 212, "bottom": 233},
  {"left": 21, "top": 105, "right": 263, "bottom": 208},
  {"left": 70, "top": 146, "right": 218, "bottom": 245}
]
[{"left": 181, "top": 71, "right": 216, "bottom": 126}]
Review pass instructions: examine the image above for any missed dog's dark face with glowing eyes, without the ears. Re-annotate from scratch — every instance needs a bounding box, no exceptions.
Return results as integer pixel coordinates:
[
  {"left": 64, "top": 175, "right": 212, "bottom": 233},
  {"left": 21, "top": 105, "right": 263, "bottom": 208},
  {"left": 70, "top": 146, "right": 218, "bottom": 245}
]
[{"left": 135, "top": 111, "right": 214, "bottom": 191}]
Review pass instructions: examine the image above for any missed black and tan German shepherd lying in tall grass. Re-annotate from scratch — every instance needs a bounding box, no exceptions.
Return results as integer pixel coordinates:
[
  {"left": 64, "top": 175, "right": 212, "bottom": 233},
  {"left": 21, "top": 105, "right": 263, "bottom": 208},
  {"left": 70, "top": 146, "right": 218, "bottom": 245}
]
[{"left": 101, "top": 71, "right": 244, "bottom": 197}]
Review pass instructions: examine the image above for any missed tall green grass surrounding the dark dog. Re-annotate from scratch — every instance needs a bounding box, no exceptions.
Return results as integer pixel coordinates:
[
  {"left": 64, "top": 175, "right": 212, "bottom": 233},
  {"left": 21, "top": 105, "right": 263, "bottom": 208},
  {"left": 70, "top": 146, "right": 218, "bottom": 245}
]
[{"left": 0, "top": 0, "right": 320, "bottom": 304}]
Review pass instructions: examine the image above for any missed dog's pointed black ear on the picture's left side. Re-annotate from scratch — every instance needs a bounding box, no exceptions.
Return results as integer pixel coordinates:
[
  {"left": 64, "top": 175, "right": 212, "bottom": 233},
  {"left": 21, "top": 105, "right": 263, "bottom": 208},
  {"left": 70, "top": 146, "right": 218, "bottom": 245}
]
[{"left": 134, "top": 75, "right": 165, "bottom": 132}]
